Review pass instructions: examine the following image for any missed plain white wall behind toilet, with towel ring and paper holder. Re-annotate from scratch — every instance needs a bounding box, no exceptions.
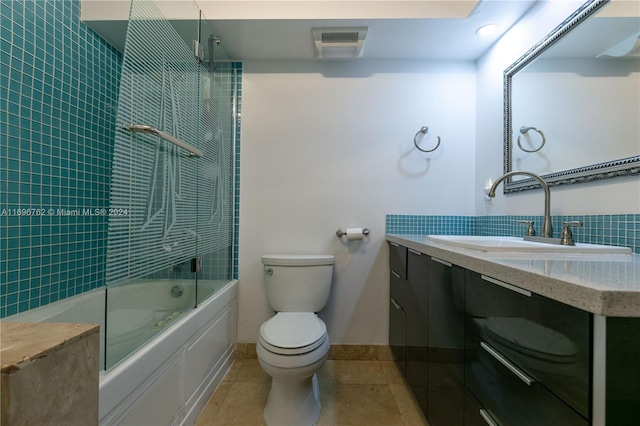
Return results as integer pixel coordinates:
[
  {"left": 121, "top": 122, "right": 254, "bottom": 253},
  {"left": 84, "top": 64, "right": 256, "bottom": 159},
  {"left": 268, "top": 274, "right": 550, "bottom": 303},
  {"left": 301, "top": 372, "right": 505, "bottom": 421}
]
[{"left": 238, "top": 61, "right": 476, "bottom": 344}]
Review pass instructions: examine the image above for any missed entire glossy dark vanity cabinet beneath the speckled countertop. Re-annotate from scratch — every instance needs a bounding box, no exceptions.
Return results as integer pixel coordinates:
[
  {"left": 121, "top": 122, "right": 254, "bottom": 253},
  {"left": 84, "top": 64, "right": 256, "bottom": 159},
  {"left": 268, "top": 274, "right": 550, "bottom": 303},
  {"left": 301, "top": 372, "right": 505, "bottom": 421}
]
[{"left": 389, "top": 238, "right": 640, "bottom": 426}]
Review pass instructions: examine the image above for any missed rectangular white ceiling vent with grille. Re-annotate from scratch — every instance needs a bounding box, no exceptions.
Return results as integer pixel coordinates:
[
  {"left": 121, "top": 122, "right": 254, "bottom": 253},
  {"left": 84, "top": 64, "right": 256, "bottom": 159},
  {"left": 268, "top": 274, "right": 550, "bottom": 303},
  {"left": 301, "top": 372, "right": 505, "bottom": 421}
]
[{"left": 311, "top": 27, "right": 368, "bottom": 59}]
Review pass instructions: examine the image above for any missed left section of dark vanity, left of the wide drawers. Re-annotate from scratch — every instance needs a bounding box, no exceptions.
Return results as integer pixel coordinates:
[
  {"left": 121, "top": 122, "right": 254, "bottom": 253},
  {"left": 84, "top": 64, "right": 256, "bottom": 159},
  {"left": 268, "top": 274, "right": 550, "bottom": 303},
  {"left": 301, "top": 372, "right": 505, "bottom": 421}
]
[{"left": 389, "top": 245, "right": 465, "bottom": 426}]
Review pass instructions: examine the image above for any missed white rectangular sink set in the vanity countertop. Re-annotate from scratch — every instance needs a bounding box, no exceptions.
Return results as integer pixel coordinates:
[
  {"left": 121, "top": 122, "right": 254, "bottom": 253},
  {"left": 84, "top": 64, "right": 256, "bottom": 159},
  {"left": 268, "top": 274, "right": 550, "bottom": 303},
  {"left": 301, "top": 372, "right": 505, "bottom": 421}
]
[{"left": 427, "top": 235, "right": 631, "bottom": 254}]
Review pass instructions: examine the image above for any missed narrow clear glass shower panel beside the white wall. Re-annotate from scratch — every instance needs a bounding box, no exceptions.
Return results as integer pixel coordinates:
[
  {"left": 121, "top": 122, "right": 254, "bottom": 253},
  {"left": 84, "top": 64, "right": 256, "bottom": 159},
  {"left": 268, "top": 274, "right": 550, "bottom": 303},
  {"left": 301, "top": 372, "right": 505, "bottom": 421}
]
[{"left": 197, "top": 14, "right": 237, "bottom": 303}]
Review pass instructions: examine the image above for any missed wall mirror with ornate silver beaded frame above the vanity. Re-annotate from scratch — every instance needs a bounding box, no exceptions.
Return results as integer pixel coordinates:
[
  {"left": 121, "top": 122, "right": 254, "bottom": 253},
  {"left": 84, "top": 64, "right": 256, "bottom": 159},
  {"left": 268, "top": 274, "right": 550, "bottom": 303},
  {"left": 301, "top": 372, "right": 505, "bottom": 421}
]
[{"left": 504, "top": 0, "right": 640, "bottom": 192}]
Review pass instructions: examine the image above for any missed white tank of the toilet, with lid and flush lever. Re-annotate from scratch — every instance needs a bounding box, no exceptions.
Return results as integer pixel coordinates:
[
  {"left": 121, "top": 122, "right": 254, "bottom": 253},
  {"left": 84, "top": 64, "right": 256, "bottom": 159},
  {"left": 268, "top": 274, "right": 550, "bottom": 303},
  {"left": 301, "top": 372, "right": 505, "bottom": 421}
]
[{"left": 262, "top": 254, "right": 333, "bottom": 312}]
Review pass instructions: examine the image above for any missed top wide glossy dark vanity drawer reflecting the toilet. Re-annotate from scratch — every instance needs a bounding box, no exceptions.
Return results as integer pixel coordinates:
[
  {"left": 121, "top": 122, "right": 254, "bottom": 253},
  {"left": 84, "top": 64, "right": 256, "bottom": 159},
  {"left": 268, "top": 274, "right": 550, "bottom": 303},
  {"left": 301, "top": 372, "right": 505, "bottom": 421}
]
[{"left": 465, "top": 271, "right": 592, "bottom": 418}]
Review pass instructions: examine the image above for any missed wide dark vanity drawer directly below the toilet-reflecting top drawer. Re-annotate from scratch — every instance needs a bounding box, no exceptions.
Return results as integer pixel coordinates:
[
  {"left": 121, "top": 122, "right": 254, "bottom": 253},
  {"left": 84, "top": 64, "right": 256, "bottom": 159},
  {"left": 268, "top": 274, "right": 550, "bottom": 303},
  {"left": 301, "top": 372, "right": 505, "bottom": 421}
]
[{"left": 465, "top": 329, "right": 589, "bottom": 426}]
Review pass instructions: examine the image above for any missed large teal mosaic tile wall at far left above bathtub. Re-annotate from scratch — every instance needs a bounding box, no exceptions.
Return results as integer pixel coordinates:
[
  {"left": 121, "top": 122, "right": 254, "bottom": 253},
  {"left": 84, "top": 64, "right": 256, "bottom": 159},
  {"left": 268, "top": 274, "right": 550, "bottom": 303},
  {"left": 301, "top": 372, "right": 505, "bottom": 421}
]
[{"left": 0, "top": 0, "right": 122, "bottom": 317}]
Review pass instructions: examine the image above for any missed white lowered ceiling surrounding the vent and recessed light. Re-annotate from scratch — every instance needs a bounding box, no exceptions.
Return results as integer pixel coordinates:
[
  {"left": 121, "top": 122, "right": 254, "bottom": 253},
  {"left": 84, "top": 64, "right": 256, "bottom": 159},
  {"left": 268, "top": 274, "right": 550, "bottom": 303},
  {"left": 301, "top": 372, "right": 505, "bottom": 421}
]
[{"left": 209, "top": 0, "right": 535, "bottom": 60}]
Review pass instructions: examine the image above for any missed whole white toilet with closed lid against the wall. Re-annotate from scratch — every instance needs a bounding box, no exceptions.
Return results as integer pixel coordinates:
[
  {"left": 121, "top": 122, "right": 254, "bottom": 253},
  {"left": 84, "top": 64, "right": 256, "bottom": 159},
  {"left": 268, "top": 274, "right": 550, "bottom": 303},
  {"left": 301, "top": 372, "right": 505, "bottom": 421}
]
[{"left": 256, "top": 255, "right": 333, "bottom": 426}]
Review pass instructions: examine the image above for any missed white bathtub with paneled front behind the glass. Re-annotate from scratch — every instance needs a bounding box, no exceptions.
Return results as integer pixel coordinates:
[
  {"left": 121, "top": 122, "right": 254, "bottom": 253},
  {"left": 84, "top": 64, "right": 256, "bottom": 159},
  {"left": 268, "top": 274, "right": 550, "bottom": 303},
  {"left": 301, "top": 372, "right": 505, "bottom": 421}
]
[{"left": 3, "top": 280, "right": 237, "bottom": 426}]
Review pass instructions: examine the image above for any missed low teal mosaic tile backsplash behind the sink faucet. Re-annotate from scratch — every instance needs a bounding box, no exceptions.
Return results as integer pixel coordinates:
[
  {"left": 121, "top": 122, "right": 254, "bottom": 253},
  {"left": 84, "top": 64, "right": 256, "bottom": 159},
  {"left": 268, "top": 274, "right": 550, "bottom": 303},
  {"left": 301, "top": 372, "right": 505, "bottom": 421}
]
[{"left": 386, "top": 214, "right": 640, "bottom": 253}]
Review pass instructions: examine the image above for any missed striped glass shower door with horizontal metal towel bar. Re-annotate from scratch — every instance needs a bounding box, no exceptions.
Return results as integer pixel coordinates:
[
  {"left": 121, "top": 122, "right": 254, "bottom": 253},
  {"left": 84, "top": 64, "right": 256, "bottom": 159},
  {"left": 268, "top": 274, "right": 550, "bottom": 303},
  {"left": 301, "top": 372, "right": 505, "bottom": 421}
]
[{"left": 105, "top": 0, "right": 205, "bottom": 369}]
